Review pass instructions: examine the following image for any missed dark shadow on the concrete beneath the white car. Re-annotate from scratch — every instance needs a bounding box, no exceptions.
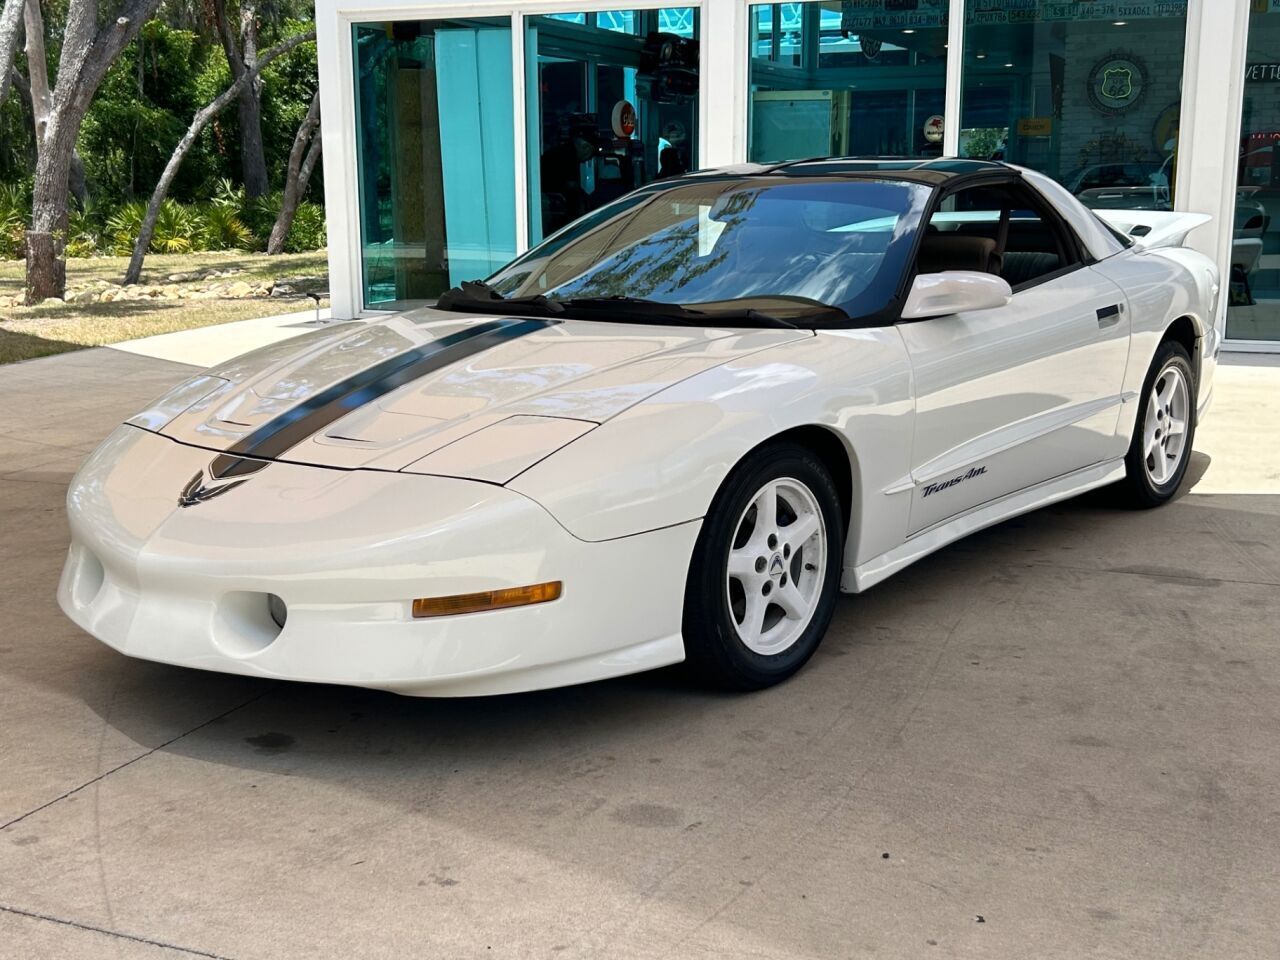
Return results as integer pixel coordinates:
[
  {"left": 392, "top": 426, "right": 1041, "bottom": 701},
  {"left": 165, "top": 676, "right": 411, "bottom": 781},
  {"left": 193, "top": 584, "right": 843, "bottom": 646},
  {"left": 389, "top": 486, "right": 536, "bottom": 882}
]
[{"left": 15, "top": 454, "right": 1274, "bottom": 803}]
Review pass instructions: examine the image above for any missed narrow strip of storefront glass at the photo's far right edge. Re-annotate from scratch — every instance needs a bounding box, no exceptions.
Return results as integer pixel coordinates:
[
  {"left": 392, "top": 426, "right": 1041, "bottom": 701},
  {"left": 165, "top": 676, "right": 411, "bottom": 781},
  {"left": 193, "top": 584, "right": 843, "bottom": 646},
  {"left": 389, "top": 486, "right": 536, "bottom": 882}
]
[{"left": 1226, "top": 4, "right": 1280, "bottom": 340}]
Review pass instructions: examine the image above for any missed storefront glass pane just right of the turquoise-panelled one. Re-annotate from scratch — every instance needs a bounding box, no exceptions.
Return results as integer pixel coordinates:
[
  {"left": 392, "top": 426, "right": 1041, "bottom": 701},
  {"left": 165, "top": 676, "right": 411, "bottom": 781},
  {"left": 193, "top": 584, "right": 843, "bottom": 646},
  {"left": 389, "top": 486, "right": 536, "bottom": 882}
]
[{"left": 525, "top": 6, "right": 699, "bottom": 243}]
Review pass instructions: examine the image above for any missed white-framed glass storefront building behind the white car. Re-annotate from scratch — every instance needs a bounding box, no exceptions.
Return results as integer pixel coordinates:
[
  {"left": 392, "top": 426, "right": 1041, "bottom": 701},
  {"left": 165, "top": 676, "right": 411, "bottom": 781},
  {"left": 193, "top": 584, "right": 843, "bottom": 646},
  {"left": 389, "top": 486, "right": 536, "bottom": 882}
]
[{"left": 316, "top": 0, "right": 1280, "bottom": 352}]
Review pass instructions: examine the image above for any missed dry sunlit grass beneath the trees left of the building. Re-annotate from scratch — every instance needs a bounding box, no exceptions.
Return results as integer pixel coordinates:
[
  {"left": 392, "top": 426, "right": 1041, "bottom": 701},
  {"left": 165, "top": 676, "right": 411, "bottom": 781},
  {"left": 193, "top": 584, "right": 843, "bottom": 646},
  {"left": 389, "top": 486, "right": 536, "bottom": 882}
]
[{"left": 0, "top": 251, "right": 329, "bottom": 364}]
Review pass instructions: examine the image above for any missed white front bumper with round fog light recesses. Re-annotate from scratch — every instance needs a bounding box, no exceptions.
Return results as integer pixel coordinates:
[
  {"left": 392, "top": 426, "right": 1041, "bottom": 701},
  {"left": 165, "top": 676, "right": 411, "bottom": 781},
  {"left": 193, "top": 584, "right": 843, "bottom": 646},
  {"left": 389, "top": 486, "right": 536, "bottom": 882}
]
[{"left": 58, "top": 426, "right": 699, "bottom": 696}]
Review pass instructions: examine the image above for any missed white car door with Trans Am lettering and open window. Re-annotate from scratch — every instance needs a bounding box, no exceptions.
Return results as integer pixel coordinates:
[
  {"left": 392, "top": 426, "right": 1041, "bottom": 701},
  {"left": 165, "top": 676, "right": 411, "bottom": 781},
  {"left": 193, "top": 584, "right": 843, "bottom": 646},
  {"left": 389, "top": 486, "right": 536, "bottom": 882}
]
[{"left": 899, "top": 184, "right": 1129, "bottom": 535}]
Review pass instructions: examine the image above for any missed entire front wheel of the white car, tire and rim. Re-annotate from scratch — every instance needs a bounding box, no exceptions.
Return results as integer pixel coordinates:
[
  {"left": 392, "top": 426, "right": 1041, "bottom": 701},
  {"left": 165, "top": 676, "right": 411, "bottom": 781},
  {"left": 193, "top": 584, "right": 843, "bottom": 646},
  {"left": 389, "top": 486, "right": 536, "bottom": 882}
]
[{"left": 684, "top": 443, "right": 844, "bottom": 690}]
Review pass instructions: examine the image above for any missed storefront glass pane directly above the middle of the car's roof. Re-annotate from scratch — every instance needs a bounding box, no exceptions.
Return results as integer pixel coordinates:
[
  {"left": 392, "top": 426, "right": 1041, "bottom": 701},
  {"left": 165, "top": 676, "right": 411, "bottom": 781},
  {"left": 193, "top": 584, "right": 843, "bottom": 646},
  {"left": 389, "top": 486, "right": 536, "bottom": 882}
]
[{"left": 748, "top": 0, "right": 948, "bottom": 163}]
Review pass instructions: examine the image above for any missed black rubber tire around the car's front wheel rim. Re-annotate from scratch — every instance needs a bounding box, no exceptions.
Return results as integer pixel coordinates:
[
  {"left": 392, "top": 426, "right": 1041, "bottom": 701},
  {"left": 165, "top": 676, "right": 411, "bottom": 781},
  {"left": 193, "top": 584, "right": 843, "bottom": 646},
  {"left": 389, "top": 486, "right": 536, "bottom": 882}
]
[{"left": 684, "top": 442, "right": 845, "bottom": 690}]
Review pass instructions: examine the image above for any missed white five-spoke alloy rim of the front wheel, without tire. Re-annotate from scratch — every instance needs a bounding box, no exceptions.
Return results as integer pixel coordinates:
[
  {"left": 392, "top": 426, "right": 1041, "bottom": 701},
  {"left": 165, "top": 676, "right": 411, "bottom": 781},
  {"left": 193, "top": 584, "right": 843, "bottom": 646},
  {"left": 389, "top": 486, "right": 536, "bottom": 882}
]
[{"left": 724, "top": 477, "right": 828, "bottom": 657}]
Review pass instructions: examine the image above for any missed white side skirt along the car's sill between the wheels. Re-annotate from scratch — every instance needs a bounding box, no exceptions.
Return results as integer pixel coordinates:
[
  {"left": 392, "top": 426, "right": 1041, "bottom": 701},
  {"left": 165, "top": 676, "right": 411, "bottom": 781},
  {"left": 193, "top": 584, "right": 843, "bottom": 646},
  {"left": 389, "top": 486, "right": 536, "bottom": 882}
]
[{"left": 840, "top": 458, "right": 1124, "bottom": 594}]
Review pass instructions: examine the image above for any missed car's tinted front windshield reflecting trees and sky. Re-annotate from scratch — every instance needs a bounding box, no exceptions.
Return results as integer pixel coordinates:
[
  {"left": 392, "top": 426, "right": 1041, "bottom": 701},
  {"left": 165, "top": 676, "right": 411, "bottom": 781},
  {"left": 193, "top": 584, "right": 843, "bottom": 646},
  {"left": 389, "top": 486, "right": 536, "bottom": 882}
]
[{"left": 488, "top": 177, "right": 929, "bottom": 325}]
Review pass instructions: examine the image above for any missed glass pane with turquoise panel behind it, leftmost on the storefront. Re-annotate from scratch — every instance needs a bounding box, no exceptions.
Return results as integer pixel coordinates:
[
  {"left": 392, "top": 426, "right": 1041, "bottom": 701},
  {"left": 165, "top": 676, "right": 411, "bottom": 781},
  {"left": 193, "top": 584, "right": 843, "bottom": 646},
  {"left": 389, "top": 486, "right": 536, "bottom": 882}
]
[{"left": 352, "top": 18, "right": 516, "bottom": 308}]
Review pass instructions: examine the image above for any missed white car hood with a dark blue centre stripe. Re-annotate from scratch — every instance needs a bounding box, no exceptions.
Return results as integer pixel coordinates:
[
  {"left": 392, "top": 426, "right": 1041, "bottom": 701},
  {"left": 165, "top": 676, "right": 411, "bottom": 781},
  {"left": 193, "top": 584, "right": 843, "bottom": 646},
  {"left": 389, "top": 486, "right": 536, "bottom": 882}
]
[{"left": 149, "top": 308, "right": 813, "bottom": 483}]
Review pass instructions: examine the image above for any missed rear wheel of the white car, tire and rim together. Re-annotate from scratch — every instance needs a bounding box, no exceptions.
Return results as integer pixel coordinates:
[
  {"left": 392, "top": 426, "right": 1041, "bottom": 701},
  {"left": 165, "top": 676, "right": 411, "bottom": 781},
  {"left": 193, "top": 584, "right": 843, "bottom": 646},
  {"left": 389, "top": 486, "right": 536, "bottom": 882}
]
[{"left": 1124, "top": 340, "right": 1196, "bottom": 507}]
